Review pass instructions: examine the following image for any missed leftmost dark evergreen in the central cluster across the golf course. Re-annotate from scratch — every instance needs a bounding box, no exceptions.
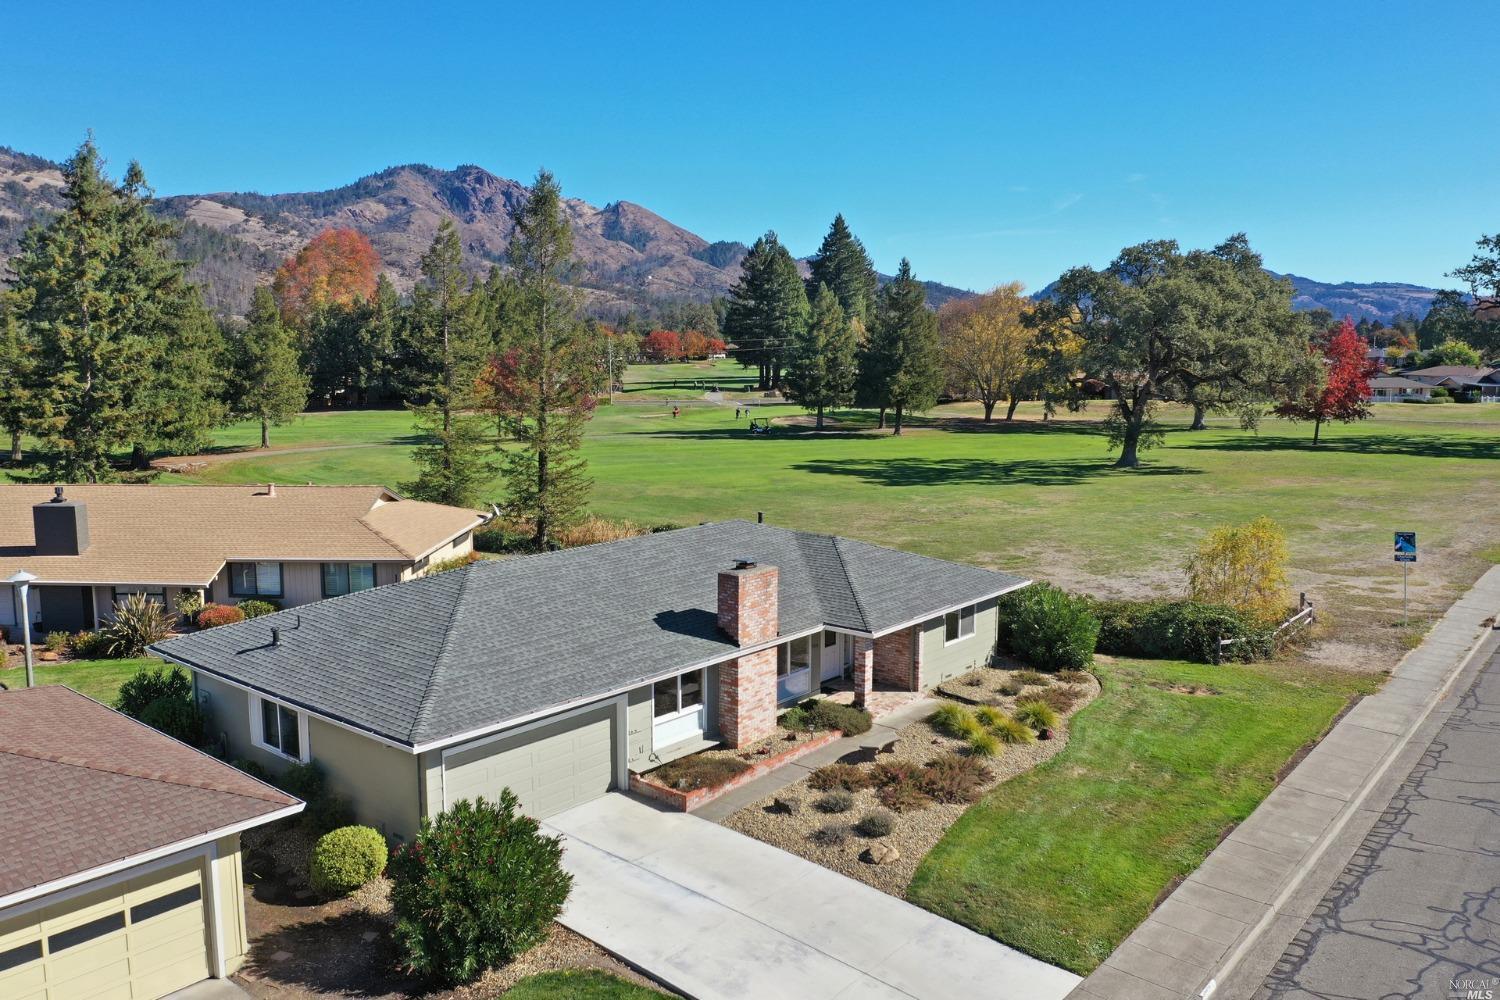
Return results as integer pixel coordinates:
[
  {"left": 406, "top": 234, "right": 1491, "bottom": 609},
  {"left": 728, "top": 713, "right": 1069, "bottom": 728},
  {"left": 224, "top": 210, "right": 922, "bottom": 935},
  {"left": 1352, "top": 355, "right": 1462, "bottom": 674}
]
[{"left": 723, "top": 232, "right": 807, "bottom": 388}]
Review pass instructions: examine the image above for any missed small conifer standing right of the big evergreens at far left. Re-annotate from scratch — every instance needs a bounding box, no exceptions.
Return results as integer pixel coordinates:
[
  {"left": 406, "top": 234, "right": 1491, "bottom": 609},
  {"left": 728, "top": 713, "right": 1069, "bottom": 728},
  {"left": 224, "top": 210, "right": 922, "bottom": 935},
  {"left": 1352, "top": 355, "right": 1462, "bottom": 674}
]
[{"left": 231, "top": 286, "right": 308, "bottom": 448}]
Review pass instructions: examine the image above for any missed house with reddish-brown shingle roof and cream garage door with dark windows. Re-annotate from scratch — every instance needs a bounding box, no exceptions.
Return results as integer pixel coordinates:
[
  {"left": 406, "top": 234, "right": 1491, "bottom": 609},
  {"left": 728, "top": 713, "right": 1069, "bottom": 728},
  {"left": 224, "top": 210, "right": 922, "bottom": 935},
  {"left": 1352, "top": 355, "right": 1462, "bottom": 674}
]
[{"left": 0, "top": 687, "right": 303, "bottom": 1000}]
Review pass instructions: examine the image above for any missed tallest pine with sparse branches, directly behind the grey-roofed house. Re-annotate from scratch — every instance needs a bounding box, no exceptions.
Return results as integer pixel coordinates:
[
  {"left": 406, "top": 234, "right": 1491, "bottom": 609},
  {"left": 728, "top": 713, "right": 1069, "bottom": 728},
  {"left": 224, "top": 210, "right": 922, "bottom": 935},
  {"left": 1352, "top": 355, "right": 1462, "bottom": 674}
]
[{"left": 485, "top": 171, "right": 605, "bottom": 550}]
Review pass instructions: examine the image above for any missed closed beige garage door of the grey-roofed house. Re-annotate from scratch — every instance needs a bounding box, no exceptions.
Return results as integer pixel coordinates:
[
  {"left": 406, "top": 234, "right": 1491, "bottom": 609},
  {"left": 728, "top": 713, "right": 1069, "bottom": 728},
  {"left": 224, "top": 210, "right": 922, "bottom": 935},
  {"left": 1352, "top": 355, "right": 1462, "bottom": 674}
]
[{"left": 443, "top": 705, "right": 615, "bottom": 819}]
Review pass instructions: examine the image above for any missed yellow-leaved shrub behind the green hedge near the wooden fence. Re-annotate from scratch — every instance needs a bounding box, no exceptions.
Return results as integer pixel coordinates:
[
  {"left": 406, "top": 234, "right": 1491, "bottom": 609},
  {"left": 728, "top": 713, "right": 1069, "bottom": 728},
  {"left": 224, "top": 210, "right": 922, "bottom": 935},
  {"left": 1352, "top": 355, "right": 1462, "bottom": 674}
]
[{"left": 1188, "top": 517, "right": 1292, "bottom": 622}]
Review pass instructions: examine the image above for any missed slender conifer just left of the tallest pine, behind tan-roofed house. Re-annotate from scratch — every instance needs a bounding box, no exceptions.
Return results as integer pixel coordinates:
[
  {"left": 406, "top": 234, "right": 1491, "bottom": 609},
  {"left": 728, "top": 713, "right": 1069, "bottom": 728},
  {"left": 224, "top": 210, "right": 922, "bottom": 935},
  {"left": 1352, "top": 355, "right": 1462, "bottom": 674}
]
[{"left": 402, "top": 219, "right": 492, "bottom": 507}]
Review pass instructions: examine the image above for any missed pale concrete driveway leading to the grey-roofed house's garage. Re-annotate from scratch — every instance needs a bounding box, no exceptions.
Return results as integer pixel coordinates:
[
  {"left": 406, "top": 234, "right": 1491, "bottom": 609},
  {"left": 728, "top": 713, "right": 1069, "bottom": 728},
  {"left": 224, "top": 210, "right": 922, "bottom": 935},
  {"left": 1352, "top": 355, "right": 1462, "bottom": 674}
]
[{"left": 545, "top": 793, "right": 1079, "bottom": 1000}]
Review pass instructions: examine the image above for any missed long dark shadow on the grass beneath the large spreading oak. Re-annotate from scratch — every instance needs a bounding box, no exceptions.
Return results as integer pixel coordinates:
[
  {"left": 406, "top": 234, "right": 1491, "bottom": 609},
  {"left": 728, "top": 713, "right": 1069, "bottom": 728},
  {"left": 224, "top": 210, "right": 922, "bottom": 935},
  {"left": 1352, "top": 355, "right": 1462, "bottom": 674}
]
[{"left": 792, "top": 459, "right": 1203, "bottom": 486}]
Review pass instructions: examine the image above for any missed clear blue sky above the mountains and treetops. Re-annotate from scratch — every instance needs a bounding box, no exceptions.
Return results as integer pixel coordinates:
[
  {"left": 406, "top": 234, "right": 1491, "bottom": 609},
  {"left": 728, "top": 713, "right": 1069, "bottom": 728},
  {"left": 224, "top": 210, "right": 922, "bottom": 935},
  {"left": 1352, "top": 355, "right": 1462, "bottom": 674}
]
[{"left": 0, "top": 0, "right": 1500, "bottom": 288}]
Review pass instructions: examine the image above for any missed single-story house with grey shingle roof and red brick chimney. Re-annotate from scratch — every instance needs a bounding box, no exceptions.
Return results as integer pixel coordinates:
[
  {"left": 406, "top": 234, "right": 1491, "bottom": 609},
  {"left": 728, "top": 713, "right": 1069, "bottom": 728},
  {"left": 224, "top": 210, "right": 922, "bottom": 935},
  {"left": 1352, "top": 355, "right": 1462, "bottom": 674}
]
[{"left": 152, "top": 520, "right": 1029, "bottom": 838}]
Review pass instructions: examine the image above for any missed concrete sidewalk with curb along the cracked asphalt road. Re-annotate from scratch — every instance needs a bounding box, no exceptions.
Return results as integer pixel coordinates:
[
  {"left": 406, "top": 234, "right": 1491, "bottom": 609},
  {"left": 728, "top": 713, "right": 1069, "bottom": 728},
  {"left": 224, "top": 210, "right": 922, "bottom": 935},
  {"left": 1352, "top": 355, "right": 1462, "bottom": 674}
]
[{"left": 1070, "top": 567, "right": 1500, "bottom": 1000}]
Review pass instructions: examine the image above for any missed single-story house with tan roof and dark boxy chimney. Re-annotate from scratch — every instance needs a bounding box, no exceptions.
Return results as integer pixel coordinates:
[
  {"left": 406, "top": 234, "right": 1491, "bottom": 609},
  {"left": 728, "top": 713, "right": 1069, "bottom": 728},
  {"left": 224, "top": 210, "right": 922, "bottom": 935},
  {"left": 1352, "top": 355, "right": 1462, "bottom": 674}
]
[{"left": 0, "top": 484, "right": 485, "bottom": 631}]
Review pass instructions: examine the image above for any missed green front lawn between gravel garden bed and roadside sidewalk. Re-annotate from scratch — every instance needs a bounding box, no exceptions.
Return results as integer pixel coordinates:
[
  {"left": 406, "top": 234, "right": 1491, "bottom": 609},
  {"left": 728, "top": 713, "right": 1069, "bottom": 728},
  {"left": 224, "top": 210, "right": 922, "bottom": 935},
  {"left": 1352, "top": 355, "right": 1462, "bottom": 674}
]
[{"left": 908, "top": 661, "right": 1380, "bottom": 975}]
